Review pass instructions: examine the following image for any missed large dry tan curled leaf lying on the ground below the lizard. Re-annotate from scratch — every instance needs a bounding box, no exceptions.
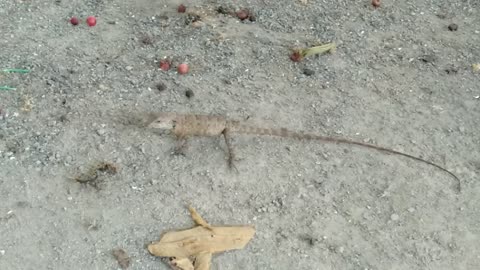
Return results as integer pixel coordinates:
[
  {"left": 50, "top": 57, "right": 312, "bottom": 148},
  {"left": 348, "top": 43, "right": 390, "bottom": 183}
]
[{"left": 148, "top": 206, "right": 255, "bottom": 270}]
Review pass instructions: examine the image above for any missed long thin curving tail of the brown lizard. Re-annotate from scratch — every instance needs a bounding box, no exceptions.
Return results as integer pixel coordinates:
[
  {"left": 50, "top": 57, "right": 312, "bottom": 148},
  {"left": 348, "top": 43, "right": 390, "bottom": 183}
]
[{"left": 234, "top": 125, "right": 460, "bottom": 191}]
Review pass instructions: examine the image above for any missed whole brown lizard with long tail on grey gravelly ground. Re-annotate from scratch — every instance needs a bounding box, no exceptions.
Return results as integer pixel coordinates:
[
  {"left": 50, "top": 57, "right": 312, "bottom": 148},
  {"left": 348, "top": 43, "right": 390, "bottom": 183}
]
[{"left": 148, "top": 112, "right": 460, "bottom": 189}]
